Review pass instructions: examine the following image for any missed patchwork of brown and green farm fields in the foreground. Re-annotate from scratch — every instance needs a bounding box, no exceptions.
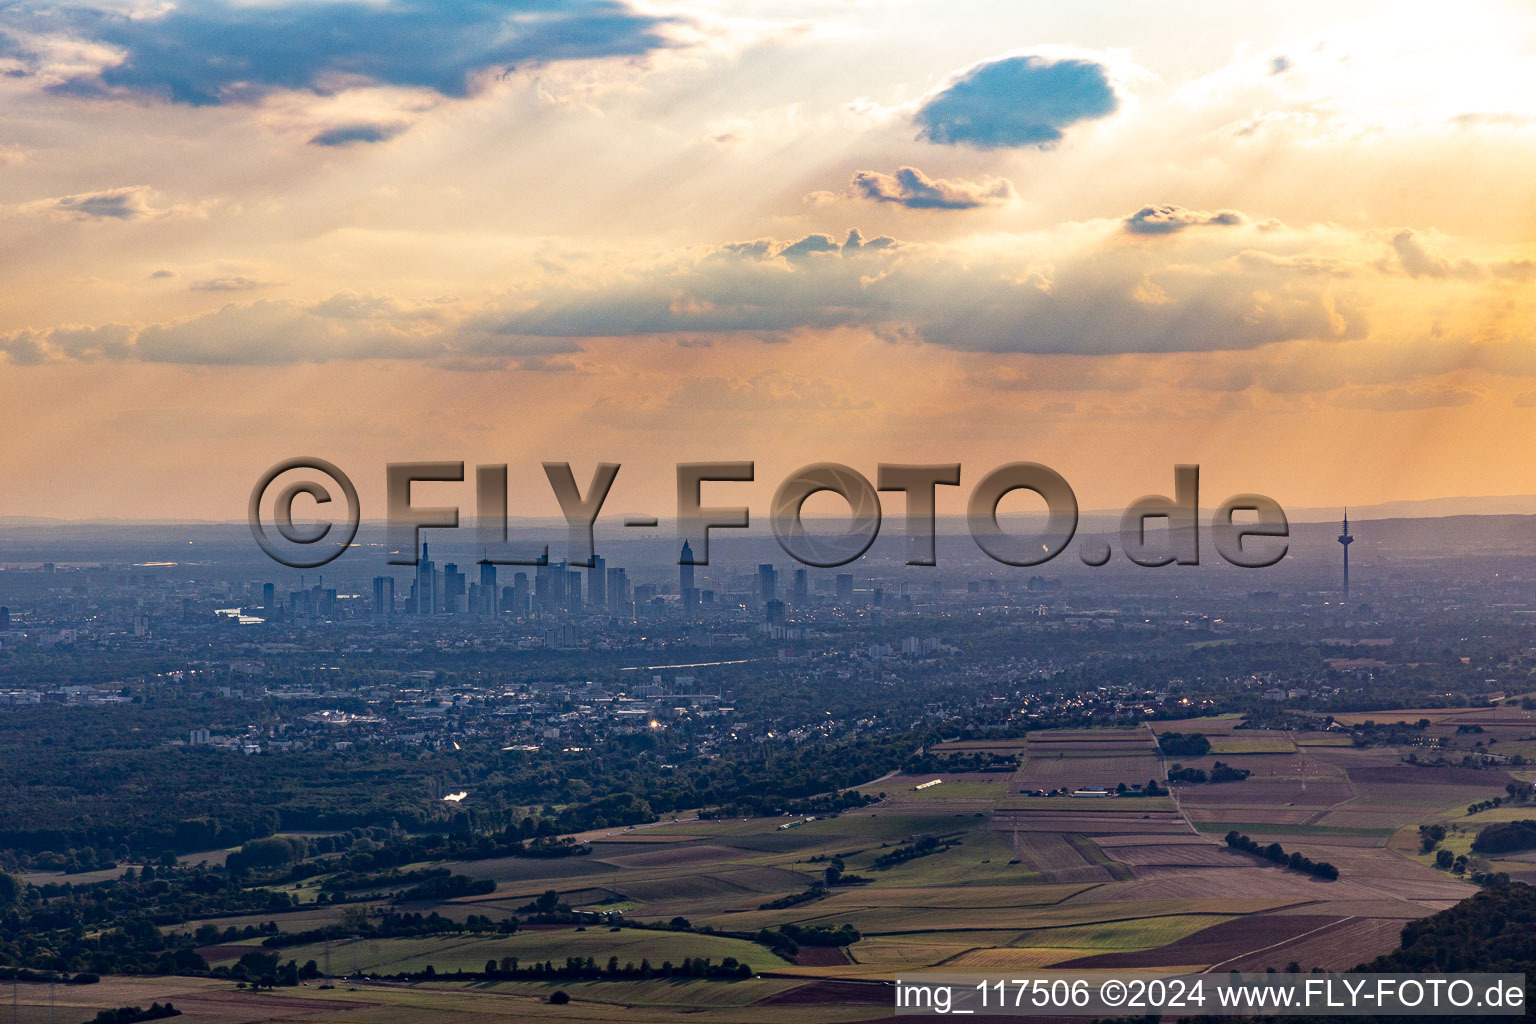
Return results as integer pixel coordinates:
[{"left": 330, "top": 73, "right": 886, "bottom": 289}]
[{"left": 146, "top": 718, "right": 1511, "bottom": 1024}]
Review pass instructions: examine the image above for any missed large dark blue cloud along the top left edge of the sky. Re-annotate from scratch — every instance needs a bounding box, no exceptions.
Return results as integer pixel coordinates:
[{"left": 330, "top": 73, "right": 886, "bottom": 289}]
[{"left": 0, "top": 0, "right": 673, "bottom": 105}]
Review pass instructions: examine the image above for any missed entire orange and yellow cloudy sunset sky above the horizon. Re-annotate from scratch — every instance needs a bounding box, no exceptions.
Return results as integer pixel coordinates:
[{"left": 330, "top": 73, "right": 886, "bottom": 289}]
[{"left": 0, "top": 0, "right": 1536, "bottom": 519}]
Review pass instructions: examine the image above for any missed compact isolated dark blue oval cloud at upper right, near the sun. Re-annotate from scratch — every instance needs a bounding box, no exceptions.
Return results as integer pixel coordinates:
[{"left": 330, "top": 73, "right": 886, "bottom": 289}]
[{"left": 912, "top": 55, "right": 1120, "bottom": 149}]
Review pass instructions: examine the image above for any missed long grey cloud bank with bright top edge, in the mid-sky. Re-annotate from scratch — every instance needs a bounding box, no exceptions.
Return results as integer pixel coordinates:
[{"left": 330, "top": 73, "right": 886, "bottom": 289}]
[{"left": 495, "top": 224, "right": 1367, "bottom": 355}]
